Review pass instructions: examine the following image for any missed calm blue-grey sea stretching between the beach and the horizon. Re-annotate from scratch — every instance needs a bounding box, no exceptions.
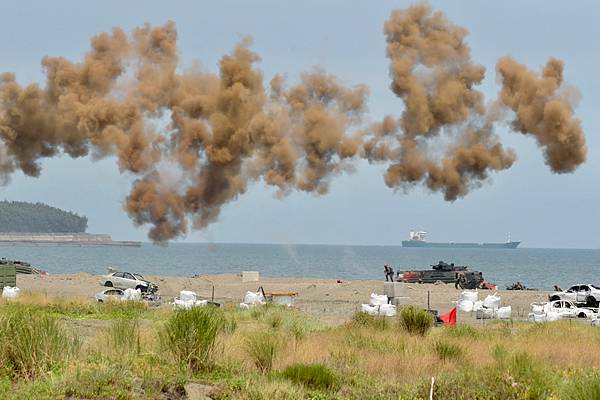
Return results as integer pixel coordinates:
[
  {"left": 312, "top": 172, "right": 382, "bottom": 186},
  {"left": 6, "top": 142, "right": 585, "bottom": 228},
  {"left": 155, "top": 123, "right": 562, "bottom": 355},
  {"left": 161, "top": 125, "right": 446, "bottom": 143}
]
[{"left": 0, "top": 243, "right": 600, "bottom": 289}]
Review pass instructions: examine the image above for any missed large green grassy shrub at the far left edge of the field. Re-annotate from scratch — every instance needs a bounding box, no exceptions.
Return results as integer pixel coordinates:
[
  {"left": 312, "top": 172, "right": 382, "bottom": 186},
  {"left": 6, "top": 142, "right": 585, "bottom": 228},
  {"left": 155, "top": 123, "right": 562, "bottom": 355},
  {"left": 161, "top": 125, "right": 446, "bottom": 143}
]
[{"left": 0, "top": 306, "right": 80, "bottom": 379}]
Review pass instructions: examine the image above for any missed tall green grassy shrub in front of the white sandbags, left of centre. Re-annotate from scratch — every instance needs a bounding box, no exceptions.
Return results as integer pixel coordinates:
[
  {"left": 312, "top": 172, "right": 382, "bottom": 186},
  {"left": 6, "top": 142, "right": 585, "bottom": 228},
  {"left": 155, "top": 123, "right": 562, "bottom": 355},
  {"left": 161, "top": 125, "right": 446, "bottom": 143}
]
[{"left": 160, "top": 307, "right": 223, "bottom": 372}]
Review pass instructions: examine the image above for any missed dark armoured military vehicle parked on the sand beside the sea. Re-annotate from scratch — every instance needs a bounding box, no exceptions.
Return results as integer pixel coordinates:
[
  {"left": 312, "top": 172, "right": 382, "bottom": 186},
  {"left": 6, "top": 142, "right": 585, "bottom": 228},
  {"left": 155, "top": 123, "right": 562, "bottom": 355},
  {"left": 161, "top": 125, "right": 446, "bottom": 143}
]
[{"left": 397, "top": 261, "right": 483, "bottom": 289}]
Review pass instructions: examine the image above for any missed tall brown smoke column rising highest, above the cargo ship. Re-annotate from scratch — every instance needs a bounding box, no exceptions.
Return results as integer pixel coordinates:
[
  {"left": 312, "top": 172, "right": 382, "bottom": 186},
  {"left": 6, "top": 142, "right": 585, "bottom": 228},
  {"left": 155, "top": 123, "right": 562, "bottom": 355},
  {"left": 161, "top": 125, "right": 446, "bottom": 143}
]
[{"left": 364, "top": 4, "right": 516, "bottom": 200}]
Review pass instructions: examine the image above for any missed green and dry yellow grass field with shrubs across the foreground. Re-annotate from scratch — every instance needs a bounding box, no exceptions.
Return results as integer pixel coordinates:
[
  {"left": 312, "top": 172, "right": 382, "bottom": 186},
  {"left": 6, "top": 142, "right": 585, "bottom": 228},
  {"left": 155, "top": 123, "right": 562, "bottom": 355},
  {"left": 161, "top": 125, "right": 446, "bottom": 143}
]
[{"left": 0, "top": 295, "right": 600, "bottom": 400}]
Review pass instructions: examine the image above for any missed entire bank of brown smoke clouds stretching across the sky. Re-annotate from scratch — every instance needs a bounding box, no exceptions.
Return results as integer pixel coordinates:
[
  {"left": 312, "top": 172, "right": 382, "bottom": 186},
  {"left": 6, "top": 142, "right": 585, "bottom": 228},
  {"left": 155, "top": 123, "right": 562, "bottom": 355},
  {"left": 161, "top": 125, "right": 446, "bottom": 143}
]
[{"left": 0, "top": 5, "right": 586, "bottom": 241}]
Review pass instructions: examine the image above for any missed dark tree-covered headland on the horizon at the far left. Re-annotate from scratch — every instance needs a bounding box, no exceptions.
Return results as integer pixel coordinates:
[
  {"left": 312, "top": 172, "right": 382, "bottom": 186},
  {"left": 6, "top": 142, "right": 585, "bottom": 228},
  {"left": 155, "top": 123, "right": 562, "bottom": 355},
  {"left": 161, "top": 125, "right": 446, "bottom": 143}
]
[{"left": 0, "top": 200, "right": 88, "bottom": 233}]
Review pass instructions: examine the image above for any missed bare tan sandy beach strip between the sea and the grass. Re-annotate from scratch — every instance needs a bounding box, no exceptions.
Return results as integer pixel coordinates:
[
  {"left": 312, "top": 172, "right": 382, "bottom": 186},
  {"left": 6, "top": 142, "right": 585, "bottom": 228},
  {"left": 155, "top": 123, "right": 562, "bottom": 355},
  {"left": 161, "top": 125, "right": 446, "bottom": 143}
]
[{"left": 17, "top": 272, "right": 548, "bottom": 325}]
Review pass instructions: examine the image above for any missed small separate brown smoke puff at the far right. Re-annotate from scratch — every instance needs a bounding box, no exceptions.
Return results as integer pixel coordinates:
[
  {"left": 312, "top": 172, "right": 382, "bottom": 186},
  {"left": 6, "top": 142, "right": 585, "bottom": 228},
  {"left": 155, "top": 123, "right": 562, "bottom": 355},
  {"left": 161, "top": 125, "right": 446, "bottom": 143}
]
[{"left": 496, "top": 57, "right": 587, "bottom": 173}]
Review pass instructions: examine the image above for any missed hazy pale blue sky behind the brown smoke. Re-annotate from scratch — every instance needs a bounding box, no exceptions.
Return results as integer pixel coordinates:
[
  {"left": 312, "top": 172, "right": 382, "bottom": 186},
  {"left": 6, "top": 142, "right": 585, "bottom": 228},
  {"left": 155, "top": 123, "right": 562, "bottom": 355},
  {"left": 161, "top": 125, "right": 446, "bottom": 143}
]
[{"left": 0, "top": 0, "right": 600, "bottom": 248}]
